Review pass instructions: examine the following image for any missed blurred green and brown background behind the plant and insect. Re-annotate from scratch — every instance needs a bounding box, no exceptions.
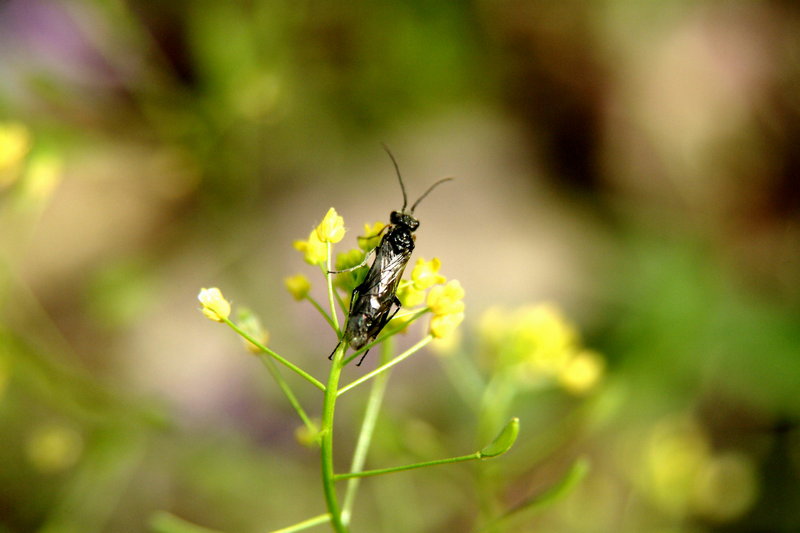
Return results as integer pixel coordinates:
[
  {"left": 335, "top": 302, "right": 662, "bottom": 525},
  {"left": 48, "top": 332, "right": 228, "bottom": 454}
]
[{"left": 0, "top": 0, "right": 800, "bottom": 533}]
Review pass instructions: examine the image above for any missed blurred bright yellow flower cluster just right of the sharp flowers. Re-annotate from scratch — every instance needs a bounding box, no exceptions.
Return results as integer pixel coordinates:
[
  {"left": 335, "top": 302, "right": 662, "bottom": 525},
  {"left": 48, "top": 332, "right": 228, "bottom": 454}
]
[{"left": 480, "top": 303, "right": 604, "bottom": 394}]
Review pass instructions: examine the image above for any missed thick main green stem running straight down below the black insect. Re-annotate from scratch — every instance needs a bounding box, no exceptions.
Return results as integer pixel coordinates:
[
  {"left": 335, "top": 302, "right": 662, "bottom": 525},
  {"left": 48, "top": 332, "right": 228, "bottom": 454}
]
[{"left": 320, "top": 343, "right": 347, "bottom": 533}]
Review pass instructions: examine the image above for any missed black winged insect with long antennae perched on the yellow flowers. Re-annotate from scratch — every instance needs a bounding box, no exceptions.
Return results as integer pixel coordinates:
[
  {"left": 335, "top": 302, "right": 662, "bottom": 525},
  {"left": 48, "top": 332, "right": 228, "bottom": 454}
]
[{"left": 328, "top": 150, "right": 453, "bottom": 365}]
